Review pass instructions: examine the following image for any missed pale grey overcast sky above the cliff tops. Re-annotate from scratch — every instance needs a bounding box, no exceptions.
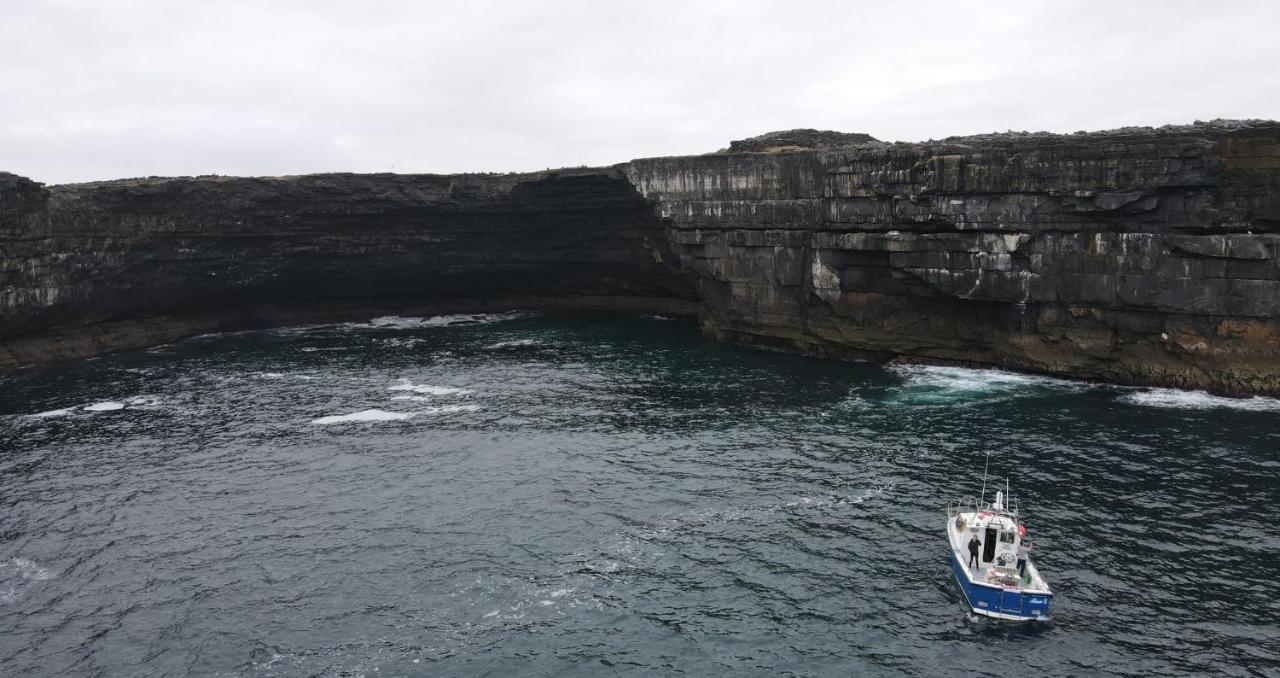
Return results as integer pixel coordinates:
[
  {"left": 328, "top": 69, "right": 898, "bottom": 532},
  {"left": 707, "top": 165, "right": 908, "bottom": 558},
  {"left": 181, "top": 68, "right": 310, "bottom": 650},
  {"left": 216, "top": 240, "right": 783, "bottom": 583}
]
[{"left": 0, "top": 0, "right": 1280, "bottom": 183}]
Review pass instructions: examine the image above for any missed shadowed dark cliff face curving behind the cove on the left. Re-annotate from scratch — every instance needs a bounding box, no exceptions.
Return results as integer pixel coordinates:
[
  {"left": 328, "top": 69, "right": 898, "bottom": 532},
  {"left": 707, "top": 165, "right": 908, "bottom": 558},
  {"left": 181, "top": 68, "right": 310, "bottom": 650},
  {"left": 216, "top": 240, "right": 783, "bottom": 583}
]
[{"left": 0, "top": 169, "right": 692, "bottom": 366}]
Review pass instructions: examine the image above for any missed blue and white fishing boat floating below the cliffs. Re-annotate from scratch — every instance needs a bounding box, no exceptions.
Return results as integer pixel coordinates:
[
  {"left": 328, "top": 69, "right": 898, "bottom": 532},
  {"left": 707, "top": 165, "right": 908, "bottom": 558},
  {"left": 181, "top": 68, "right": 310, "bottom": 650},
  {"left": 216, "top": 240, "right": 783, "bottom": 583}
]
[{"left": 947, "top": 471, "right": 1053, "bottom": 622}]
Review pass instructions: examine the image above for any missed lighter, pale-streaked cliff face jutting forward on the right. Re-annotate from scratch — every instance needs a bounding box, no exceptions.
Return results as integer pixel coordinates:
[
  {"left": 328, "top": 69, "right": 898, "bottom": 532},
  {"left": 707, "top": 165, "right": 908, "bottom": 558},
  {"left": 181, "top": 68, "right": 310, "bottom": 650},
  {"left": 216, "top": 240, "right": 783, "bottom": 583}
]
[{"left": 627, "top": 123, "right": 1280, "bottom": 394}]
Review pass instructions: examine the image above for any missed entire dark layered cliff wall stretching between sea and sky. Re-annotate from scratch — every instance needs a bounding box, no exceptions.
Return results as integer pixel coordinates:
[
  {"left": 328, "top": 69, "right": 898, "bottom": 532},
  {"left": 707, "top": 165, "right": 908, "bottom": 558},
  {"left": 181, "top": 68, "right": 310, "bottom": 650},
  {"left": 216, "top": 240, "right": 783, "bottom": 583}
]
[{"left": 0, "top": 120, "right": 1280, "bottom": 394}]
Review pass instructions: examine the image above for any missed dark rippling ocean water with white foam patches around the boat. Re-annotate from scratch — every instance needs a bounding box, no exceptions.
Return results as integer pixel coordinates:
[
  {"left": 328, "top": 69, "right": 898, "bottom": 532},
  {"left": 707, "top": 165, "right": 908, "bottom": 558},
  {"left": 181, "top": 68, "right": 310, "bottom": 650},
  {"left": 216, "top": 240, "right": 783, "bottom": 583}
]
[{"left": 0, "top": 315, "right": 1280, "bottom": 675}]
